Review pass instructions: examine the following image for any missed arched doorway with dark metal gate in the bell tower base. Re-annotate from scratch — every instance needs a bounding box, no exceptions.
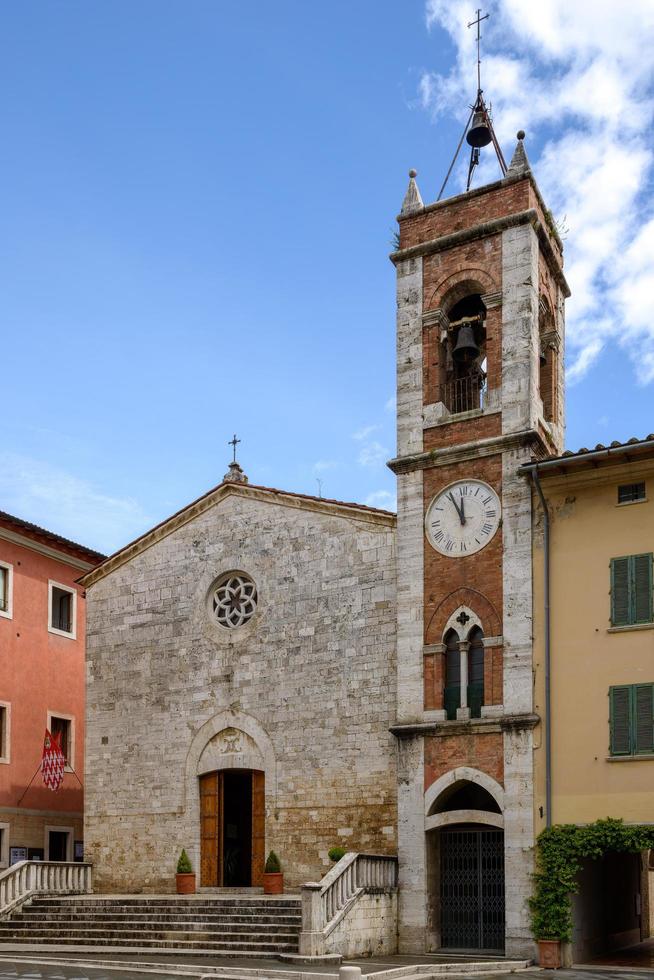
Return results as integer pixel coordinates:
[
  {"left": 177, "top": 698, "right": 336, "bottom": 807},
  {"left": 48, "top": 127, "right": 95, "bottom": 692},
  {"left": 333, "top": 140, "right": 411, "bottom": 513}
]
[{"left": 425, "top": 779, "right": 505, "bottom": 953}]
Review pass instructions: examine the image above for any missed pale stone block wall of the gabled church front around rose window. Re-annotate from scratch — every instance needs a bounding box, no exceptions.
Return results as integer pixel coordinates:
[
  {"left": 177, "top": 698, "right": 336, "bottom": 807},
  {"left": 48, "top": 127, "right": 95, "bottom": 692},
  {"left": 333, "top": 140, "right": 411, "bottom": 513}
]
[{"left": 85, "top": 487, "right": 396, "bottom": 891}]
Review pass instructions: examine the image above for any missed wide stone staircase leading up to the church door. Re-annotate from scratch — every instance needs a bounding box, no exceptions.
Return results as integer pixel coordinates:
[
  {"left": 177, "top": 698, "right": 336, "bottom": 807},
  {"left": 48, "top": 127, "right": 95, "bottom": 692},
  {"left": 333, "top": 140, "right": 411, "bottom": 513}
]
[{"left": 0, "top": 895, "right": 301, "bottom": 957}]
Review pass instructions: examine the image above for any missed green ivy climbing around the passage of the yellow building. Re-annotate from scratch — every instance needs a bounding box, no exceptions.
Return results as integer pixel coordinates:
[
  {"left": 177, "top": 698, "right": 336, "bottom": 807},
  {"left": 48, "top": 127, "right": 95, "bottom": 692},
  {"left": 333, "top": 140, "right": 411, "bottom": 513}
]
[{"left": 529, "top": 817, "right": 654, "bottom": 942}]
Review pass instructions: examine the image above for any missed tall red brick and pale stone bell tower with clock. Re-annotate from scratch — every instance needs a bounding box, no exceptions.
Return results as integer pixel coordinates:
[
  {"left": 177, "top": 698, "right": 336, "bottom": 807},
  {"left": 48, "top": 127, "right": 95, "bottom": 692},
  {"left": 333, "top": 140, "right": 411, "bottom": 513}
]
[{"left": 389, "top": 134, "right": 569, "bottom": 955}]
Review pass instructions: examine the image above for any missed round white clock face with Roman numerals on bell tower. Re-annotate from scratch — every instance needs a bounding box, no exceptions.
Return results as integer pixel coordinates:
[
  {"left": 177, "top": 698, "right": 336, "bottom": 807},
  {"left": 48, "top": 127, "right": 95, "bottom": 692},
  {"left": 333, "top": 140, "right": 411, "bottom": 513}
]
[{"left": 425, "top": 480, "right": 501, "bottom": 558}]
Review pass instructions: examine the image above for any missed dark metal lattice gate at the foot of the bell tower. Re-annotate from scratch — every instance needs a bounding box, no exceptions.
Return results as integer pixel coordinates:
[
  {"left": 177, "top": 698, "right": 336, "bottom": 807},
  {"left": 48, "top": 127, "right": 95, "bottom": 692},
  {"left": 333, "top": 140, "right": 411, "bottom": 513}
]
[{"left": 440, "top": 828, "right": 504, "bottom": 951}]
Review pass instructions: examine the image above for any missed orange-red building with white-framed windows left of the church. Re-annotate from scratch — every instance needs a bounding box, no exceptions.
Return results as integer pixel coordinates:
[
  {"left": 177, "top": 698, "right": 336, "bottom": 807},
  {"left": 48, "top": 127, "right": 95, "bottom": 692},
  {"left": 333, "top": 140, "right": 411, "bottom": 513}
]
[{"left": 0, "top": 511, "right": 103, "bottom": 868}]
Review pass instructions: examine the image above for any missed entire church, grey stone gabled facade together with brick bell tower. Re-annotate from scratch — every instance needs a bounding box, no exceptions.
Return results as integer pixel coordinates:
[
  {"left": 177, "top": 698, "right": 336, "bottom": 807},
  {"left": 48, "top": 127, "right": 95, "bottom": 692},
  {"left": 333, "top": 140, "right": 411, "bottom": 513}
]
[{"left": 83, "top": 134, "right": 569, "bottom": 955}]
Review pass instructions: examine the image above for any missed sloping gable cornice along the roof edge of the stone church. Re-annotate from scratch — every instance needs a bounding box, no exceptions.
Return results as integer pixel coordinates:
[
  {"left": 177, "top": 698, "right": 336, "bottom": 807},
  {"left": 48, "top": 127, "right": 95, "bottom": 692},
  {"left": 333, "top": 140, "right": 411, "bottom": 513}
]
[{"left": 78, "top": 483, "right": 397, "bottom": 588}]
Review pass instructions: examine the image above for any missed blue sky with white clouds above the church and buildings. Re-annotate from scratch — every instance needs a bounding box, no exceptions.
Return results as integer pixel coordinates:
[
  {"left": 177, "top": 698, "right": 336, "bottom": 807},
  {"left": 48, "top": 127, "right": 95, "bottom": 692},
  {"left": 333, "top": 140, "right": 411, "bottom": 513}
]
[{"left": 0, "top": 0, "right": 654, "bottom": 551}]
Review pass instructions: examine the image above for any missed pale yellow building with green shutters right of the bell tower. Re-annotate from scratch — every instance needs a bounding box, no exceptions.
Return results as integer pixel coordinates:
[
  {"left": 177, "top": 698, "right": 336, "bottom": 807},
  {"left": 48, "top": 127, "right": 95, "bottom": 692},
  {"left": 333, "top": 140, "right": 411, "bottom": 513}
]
[{"left": 522, "top": 436, "right": 654, "bottom": 961}]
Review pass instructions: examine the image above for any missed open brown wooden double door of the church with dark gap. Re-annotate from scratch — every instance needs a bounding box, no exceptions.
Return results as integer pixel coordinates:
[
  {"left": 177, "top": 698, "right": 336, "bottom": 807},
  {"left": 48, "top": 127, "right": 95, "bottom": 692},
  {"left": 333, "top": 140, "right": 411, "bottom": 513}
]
[{"left": 200, "top": 769, "right": 266, "bottom": 888}]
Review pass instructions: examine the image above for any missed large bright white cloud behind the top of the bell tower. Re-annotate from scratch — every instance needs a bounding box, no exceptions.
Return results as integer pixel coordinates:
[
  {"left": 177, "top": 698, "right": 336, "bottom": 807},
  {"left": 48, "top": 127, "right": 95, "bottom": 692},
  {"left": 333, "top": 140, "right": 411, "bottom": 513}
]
[{"left": 418, "top": 0, "right": 654, "bottom": 384}]
